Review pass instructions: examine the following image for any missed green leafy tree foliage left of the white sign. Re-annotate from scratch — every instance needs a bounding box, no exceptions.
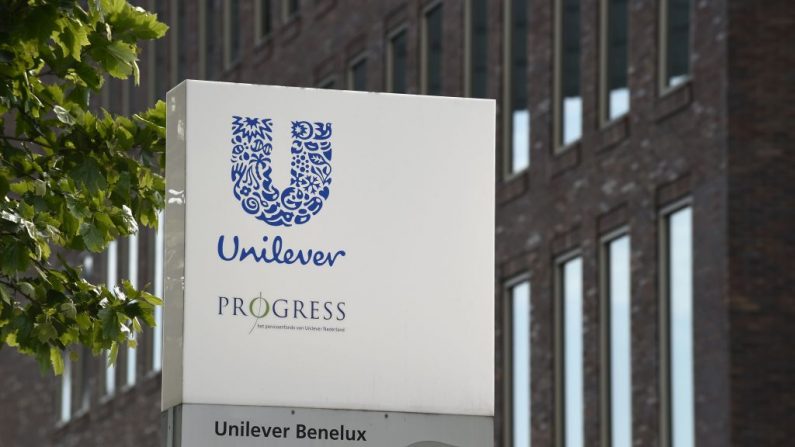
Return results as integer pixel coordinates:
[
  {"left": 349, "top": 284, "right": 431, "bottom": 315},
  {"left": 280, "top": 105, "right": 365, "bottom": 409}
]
[{"left": 0, "top": 0, "right": 167, "bottom": 373}]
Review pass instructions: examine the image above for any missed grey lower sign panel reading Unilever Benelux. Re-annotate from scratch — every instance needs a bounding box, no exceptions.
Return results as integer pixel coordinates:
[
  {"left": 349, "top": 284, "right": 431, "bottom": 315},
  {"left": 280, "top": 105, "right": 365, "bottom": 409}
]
[{"left": 162, "top": 404, "right": 494, "bottom": 447}]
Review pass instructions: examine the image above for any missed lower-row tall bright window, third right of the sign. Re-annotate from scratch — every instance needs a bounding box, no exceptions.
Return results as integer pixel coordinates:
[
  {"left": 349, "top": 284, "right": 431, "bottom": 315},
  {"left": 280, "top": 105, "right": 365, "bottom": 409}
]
[{"left": 601, "top": 234, "right": 632, "bottom": 447}]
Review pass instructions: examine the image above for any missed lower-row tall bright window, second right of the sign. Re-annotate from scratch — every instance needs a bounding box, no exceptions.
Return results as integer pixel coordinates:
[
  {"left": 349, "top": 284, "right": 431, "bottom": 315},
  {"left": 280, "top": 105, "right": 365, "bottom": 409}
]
[{"left": 555, "top": 257, "right": 585, "bottom": 447}]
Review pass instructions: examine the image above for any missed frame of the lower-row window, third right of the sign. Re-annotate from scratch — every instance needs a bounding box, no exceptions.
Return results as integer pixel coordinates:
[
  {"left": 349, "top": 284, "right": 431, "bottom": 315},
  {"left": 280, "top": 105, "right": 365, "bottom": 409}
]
[{"left": 599, "top": 229, "right": 634, "bottom": 447}]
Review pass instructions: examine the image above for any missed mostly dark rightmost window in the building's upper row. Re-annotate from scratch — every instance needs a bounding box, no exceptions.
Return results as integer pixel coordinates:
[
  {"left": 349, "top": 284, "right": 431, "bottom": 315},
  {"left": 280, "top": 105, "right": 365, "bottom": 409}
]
[{"left": 665, "top": 0, "right": 692, "bottom": 86}]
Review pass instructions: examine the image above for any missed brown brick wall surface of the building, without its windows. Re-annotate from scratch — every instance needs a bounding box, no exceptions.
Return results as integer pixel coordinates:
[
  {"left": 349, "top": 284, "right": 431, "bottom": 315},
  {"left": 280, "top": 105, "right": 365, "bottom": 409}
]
[{"left": 0, "top": 0, "right": 795, "bottom": 447}]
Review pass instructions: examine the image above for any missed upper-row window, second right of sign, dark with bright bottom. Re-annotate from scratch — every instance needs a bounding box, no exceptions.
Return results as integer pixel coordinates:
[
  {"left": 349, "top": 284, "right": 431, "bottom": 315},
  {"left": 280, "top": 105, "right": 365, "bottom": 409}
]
[{"left": 555, "top": 0, "right": 582, "bottom": 148}]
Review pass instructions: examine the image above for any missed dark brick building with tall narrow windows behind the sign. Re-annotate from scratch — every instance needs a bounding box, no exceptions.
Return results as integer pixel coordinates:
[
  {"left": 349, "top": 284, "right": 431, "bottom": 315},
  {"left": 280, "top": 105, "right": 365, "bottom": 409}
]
[{"left": 0, "top": 0, "right": 795, "bottom": 447}]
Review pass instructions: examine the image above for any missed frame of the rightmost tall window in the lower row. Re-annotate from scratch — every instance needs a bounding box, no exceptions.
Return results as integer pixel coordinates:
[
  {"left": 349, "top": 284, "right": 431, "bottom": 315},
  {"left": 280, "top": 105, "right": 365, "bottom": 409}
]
[{"left": 658, "top": 196, "right": 698, "bottom": 447}]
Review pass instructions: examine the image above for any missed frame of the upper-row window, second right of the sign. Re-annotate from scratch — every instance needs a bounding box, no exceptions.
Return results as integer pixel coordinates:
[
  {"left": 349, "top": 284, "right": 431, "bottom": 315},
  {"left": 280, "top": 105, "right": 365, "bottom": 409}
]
[{"left": 552, "top": 0, "right": 585, "bottom": 155}]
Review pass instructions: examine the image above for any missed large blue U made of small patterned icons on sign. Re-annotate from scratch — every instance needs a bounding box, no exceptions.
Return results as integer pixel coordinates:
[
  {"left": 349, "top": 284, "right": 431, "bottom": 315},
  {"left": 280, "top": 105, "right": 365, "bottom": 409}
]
[{"left": 232, "top": 116, "right": 331, "bottom": 227}]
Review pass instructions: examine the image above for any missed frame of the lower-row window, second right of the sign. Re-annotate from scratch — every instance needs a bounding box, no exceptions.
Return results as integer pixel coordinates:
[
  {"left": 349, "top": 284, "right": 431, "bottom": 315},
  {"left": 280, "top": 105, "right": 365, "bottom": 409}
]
[{"left": 553, "top": 252, "right": 585, "bottom": 447}]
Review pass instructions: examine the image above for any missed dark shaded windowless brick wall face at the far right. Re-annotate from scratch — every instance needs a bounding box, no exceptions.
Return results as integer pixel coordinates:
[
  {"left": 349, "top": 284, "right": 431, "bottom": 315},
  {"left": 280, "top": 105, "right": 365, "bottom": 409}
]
[{"left": 727, "top": 0, "right": 795, "bottom": 446}]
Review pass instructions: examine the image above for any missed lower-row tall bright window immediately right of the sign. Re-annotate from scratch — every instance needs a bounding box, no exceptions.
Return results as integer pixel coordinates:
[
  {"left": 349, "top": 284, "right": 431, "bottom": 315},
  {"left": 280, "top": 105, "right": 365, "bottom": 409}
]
[{"left": 508, "top": 280, "right": 530, "bottom": 447}]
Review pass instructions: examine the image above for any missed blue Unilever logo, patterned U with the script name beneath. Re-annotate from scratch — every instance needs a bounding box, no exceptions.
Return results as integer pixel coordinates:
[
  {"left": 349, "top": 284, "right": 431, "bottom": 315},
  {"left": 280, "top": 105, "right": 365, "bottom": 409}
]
[{"left": 217, "top": 116, "right": 345, "bottom": 267}]
